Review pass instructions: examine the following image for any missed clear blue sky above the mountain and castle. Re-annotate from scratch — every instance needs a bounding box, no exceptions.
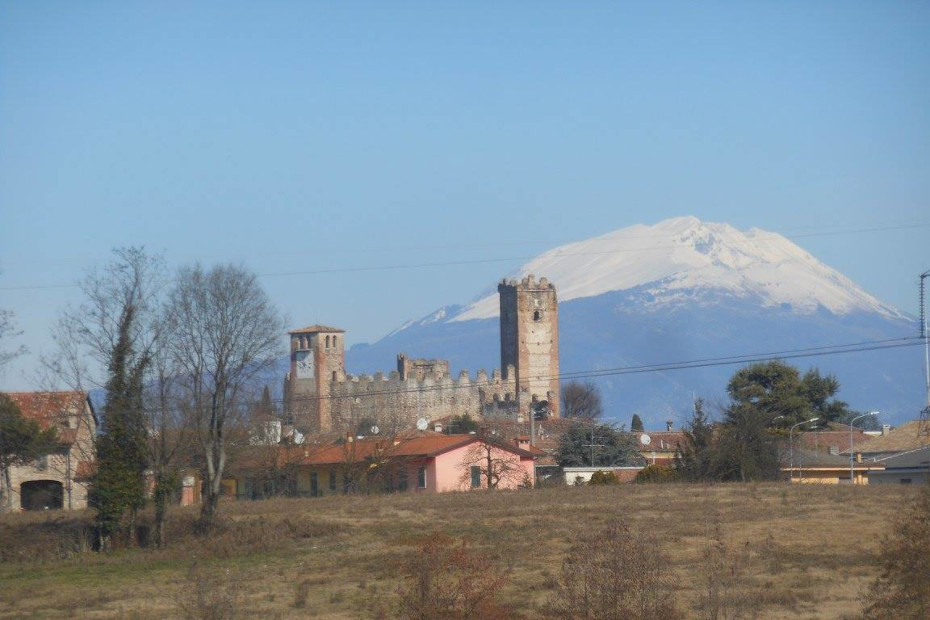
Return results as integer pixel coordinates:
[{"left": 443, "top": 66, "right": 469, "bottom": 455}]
[{"left": 0, "top": 1, "right": 930, "bottom": 389}]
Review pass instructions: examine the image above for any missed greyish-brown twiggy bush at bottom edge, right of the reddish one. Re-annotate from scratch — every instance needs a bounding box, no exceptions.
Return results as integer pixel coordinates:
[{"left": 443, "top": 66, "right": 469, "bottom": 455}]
[{"left": 550, "top": 522, "right": 678, "bottom": 620}]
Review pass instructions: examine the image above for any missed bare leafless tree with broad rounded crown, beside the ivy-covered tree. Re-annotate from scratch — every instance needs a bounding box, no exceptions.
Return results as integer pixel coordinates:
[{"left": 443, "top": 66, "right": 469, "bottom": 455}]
[{"left": 169, "top": 265, "right": 284, "bottom": 526}]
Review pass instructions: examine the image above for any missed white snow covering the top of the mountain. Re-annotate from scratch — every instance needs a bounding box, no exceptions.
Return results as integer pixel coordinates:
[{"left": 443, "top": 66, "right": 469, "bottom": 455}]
[{"left": 447, "top": 217, "right": 904, "bottom": 322}]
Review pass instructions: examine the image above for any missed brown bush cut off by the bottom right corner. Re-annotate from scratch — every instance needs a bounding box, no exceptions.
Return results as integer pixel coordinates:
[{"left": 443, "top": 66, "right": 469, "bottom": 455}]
[{"left": 864, "top": 485, "right": 930, "bottom": 620}]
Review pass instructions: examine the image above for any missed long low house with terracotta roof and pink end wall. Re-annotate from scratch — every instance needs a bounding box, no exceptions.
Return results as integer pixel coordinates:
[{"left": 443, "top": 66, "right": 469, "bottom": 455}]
[{"left": 231, "top": 432, "right": 536, "bottom": 497}]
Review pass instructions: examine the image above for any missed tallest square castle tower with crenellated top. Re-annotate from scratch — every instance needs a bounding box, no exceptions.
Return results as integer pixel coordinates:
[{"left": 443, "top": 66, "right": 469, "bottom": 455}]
[{"left": 497, "top": 275, "right": 559, "bottom": 418}]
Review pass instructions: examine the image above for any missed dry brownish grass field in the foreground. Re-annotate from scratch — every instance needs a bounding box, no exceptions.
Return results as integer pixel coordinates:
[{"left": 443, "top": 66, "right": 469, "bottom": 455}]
[{"left": 0, "top": 484, "right": 915, "bottom": 618}]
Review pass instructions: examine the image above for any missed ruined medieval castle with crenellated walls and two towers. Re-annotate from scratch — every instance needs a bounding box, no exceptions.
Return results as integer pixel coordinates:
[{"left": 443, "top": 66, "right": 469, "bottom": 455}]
[{"left": 284, "top": 275, "right": 559, "bottom": 432}]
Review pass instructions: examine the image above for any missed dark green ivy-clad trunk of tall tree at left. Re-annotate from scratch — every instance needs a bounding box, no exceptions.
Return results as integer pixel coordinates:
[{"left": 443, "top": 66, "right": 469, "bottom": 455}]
[{"left": 89, "top": 304, "right": 149, "bottom": 548}]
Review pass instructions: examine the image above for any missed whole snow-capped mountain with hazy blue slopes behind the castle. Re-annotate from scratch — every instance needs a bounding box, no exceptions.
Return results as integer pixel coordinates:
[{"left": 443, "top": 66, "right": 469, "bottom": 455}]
[{"left": 347, "top": 217, "right": 923, "bottom": 425}]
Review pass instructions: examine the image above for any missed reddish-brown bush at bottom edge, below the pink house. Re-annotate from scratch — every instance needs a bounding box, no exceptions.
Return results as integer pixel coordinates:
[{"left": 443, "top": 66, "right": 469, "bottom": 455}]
[{"left": 398, "top": 532, "right": 515, "bottom": 620}]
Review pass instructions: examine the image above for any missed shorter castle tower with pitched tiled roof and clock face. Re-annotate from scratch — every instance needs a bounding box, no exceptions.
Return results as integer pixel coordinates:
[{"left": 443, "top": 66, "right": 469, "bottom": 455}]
[{"left": 284, "top": 325, "right": 345, "bottom": 432}]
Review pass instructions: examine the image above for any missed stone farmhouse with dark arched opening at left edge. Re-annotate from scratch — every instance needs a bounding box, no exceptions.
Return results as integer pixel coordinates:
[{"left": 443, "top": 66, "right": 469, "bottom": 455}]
[{"left": 7, "top": 392, "right": 97, "bottom": 510}]
